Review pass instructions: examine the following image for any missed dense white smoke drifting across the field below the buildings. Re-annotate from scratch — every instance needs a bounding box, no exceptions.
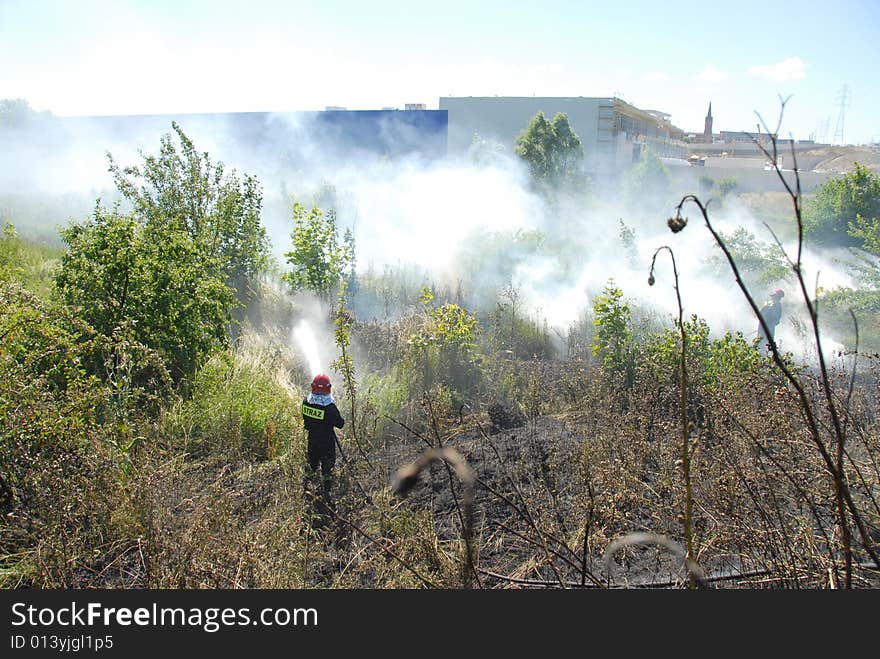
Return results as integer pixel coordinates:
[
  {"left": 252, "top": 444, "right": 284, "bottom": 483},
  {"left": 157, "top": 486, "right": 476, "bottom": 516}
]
[{"left": 0, "top": 105, "right": 868, "bottom": 364}]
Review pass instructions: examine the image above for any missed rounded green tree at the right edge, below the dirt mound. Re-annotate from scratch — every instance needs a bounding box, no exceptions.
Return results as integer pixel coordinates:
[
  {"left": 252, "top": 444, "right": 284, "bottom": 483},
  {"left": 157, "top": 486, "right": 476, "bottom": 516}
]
[{"left": 804, "top": 164, "right": 880, "bottom": 247}]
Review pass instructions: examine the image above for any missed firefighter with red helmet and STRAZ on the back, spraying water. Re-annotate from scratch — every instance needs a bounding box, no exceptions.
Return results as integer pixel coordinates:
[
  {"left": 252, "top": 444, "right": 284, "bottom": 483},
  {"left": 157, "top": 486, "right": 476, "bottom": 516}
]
[{"left": 302, "top": 373, "right": 345, "bottom": 498}]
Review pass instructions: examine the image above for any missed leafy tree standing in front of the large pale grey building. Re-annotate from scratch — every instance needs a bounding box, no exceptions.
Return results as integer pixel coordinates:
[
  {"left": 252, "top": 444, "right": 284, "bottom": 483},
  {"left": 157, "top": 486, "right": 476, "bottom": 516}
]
[{"left": 515, "top": 112, "right": 584, "bottom": 192}]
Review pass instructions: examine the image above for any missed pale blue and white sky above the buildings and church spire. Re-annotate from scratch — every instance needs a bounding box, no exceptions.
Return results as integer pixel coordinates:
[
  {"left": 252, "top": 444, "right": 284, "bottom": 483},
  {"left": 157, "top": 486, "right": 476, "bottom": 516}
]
[{"left": 0, "top": 0, "right": 880, "bottom": 143}]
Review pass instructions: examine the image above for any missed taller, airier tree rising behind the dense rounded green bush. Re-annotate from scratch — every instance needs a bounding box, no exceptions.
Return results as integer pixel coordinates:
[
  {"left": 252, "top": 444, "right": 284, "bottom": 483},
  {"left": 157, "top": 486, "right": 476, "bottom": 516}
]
[{"left": 108, "top": 122, "right": 269, "bottom": 319}]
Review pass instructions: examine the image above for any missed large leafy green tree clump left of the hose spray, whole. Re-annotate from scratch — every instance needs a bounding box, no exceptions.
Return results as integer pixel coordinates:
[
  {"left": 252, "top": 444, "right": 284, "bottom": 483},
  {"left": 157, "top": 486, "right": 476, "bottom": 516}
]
[{"left": 56, "top": 123, "right": 268, "bottom": 381}]
